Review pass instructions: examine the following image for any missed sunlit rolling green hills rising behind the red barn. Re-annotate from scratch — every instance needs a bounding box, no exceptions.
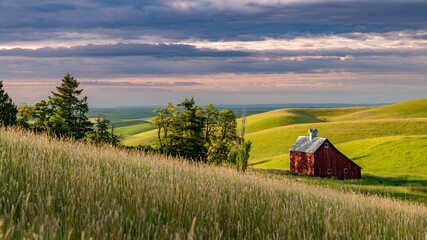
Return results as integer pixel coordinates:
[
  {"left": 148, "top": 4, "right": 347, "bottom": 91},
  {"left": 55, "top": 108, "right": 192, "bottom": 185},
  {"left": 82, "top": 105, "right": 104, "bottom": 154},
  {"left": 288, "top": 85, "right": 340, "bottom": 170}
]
[{"left": 112, "top": 98, "right": 427, "bottom": 177}]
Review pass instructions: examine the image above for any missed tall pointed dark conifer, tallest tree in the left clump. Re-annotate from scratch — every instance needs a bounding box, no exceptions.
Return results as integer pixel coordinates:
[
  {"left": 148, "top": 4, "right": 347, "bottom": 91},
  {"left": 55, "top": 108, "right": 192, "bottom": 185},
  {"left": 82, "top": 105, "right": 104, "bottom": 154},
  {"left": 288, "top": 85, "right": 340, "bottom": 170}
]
[{"left": 49, "top": 73, "right": 92, "bottom": 139}]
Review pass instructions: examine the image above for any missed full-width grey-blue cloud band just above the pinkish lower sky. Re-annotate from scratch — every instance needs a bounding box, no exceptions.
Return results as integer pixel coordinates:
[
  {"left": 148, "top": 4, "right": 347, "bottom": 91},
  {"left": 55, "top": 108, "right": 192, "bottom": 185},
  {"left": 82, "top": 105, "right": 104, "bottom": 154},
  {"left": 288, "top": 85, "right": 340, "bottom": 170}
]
[{"left": 0, "top": 51, "right": 427, "bottom": 81}]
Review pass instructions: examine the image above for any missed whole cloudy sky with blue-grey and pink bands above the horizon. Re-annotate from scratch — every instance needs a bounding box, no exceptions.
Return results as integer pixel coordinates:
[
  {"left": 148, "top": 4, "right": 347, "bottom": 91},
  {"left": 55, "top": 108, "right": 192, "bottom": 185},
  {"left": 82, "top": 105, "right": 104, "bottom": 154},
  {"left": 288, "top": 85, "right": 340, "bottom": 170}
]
[{"left": 0, "top": 0, "right": 427, "bottom": 107}]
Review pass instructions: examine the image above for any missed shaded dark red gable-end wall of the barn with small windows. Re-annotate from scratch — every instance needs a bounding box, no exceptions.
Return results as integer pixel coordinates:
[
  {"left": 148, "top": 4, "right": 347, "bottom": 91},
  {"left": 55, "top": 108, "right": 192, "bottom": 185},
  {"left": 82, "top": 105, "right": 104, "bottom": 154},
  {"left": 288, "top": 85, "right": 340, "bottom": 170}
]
[{"left": 314, "top": 141, "right": 361, "bottom": 179}]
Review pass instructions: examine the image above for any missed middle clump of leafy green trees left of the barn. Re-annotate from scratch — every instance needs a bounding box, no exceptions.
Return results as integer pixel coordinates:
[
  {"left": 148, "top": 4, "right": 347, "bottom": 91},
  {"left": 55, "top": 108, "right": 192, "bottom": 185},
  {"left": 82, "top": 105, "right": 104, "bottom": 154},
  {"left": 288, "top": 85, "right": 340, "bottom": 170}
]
[{"left": 152, "top": 98, "right": 252, "bottom": 171}]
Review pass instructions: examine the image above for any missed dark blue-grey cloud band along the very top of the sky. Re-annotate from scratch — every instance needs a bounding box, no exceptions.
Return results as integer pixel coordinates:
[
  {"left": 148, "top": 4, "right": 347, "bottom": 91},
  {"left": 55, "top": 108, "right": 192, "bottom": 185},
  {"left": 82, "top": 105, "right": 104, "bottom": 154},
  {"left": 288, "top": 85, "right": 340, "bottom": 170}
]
[{"left": 0, "top": 0, "right": 427, "bottom": 41}]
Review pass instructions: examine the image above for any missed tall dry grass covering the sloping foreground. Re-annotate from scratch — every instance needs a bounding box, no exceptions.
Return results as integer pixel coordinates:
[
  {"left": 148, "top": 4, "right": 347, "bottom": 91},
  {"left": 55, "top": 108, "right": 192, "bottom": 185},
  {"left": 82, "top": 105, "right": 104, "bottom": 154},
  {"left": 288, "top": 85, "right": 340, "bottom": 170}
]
[{"left": 0, "top": 129, "right": 427, "bottom": 239}]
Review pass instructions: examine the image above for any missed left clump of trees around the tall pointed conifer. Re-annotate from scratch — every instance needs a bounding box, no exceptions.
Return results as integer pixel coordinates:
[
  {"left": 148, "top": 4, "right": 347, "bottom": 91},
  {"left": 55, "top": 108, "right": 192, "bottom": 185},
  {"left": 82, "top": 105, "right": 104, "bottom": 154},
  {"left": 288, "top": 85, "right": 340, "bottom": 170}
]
[{"left": 9, "top": 73, "right": 120, "bottom": 146}]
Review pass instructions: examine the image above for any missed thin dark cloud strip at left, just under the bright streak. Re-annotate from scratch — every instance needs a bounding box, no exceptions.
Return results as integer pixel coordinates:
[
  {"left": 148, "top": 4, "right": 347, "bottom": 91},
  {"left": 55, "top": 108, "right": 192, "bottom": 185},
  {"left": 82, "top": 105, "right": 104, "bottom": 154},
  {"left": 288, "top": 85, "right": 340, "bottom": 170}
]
[{"left": 0, "top": 43, "right": 251, "bottom": 58}]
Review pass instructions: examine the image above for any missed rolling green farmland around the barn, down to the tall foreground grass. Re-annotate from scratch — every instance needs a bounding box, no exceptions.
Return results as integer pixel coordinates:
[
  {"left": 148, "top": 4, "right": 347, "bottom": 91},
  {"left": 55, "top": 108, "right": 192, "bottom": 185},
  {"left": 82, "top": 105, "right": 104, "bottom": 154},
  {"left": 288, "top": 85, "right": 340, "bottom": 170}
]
[{"left": 114, "top": 99, "right": 427, "bottom": 203}]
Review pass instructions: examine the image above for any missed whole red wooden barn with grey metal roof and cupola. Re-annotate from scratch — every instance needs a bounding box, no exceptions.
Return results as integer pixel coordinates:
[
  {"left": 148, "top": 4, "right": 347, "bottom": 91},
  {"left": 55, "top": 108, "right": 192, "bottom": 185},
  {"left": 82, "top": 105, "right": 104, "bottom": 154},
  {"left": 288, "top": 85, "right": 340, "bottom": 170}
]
[{"left": 290, "top": 129, "right": 362, "bottom": 179}]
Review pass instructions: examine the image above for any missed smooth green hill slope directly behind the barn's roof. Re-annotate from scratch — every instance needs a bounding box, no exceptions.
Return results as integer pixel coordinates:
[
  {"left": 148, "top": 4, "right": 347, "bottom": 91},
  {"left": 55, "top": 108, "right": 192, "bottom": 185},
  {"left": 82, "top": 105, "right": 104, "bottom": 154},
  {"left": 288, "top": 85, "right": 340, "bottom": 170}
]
[{"left": 247, "top": 118, "right": 427, "bottom": 167}]
